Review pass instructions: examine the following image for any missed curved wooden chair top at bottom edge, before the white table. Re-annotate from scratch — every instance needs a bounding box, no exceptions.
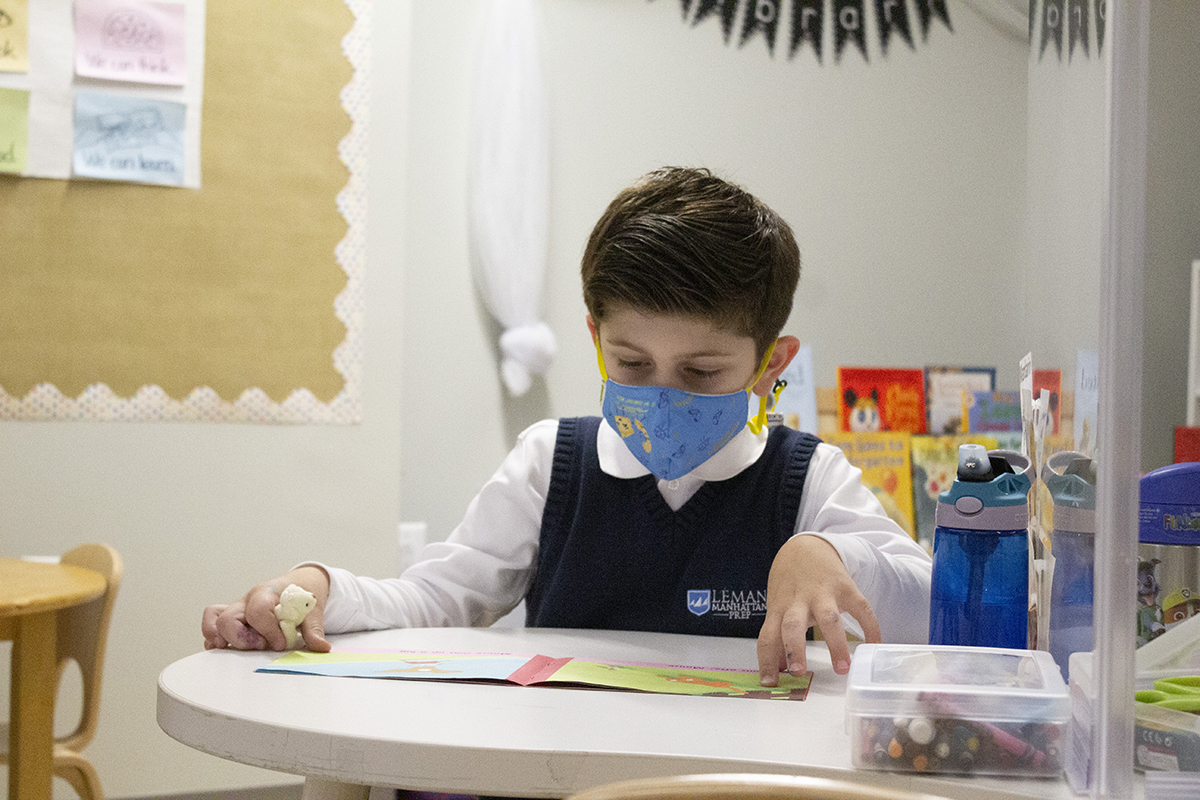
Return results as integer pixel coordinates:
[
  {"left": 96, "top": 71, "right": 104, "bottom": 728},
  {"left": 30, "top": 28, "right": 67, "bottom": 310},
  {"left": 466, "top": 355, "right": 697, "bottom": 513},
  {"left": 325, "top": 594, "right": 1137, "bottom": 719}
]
[{"left": 568, "top": 774, "right": 944, "bottom": 800}]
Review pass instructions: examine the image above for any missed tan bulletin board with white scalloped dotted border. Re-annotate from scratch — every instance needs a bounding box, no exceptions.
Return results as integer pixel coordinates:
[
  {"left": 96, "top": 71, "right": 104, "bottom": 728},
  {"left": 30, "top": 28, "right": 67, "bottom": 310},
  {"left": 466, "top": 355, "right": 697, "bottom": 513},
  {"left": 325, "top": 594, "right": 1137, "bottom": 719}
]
[{"left": 0, "top": 0, "right": 370, "bottom": 423}]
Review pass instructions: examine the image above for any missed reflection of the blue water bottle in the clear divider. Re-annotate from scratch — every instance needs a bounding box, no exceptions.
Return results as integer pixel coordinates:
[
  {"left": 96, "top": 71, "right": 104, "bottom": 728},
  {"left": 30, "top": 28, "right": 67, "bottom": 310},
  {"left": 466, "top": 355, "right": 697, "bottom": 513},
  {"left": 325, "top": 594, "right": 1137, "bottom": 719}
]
[{"left": 1042, "top": 451, "right": 1096, "bottom": 680}]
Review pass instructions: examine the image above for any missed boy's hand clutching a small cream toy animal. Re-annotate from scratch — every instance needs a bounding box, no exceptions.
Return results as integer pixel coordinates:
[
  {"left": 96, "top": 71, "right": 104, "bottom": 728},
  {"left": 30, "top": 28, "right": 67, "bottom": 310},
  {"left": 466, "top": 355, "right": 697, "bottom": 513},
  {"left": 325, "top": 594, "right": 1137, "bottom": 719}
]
[{"left": 200, "top": 566, "right": 330, "bottom": 652}]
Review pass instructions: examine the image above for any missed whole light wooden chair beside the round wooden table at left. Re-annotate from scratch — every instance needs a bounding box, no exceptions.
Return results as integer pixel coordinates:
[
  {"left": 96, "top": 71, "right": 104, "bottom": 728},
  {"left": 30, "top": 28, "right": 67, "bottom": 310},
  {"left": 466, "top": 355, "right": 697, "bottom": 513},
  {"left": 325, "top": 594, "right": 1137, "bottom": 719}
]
[{"left": 0, "top": 545, "right": 122, "bottom": 800}]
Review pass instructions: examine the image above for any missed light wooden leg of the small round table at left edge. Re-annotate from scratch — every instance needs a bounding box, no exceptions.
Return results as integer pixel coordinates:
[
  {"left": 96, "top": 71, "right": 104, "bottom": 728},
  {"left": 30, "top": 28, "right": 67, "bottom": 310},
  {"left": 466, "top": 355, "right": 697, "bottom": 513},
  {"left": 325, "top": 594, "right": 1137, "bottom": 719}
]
[{"left": 8, "top": 612, "right": 58, "bottom": 800}]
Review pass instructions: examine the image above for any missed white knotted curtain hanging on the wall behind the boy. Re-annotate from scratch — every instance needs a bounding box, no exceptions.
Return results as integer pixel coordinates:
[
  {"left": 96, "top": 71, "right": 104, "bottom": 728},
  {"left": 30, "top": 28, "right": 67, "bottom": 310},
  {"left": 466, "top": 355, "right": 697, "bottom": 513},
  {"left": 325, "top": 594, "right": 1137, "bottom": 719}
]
[{"left": 468, "top": 0, "right": 554, "bottom": 396}]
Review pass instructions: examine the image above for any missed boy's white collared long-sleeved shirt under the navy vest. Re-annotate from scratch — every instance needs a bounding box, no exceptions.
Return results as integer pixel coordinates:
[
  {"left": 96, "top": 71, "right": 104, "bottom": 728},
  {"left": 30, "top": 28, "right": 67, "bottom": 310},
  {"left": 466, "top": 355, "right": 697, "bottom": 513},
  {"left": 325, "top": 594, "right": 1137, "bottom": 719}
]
[{"left": 310, "top": 420, "right": 931, "bottom": 643}]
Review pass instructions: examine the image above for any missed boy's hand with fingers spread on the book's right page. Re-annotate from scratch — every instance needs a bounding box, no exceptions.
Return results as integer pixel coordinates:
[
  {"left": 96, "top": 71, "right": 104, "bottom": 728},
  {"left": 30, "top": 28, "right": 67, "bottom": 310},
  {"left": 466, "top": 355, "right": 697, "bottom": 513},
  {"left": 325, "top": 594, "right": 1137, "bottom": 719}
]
[{"left": 758, "top": 536, "right": 880, "bottom": 686}]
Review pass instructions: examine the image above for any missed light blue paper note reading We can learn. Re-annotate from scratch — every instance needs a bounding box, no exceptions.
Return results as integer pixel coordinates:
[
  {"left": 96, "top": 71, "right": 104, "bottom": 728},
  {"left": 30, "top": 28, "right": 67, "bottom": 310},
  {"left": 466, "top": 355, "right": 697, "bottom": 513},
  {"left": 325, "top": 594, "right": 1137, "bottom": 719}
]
[{"left": 73, "top": 90, "right": 187, "bottom": 186}]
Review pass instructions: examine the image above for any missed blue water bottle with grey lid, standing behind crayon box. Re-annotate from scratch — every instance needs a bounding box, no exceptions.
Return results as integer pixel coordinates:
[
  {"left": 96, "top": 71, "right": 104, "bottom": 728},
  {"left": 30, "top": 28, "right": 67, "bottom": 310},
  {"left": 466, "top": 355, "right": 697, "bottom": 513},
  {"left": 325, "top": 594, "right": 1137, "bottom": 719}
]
[{"left": 929, "top": 445, "right": 1032, "bottom": 649}]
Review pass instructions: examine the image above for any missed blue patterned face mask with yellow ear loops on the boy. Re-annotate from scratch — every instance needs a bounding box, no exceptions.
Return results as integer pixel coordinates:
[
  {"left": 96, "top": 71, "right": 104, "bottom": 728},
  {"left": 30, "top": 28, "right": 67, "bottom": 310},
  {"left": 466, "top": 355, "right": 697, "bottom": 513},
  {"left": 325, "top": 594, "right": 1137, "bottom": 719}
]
[{"left": 596, "top": 343, "right": 781, "bottom": 481}]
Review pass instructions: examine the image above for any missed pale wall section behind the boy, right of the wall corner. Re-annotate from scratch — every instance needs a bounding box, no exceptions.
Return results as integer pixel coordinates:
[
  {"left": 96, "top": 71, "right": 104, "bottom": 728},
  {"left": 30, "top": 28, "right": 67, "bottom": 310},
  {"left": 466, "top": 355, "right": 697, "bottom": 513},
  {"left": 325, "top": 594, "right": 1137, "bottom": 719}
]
[{"left": 401, "top": 0, "right": 1032, "bottom": 551}]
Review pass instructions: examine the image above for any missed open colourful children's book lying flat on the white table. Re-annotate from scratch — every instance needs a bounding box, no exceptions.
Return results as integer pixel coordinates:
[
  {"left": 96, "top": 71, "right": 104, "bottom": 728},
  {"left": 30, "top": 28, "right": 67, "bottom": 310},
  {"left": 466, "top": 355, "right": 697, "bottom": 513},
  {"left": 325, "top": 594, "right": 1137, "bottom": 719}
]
[{"left": 257, "top": 650, "right": 812, "bottom": 700}]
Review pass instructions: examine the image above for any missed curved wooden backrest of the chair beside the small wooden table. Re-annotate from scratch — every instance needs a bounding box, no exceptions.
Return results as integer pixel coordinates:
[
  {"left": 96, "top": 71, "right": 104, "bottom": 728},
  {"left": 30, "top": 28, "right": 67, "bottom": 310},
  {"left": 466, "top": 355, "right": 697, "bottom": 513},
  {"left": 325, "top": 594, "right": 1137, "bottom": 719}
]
[{"left": 54, "top": 543, "right": 122, "bottom": 751}]
